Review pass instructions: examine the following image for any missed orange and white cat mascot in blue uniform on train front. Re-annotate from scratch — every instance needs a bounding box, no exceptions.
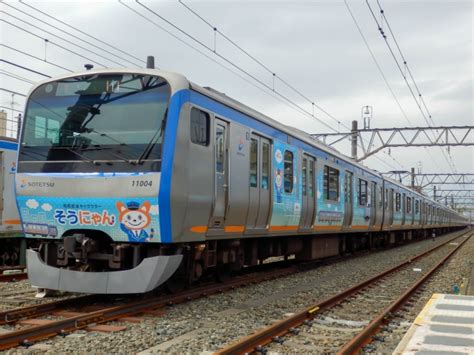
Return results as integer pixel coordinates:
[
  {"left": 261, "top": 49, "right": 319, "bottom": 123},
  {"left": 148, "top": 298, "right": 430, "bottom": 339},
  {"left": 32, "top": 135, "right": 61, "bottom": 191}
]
[{"left": 116, "top": 201, "right": 155, "bottom": 242}]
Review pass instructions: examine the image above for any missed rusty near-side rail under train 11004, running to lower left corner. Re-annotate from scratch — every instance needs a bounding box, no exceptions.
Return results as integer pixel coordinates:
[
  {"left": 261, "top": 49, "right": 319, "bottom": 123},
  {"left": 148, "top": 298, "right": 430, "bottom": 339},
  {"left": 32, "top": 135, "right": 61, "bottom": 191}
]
[{"left": 0, "top": 266, "right": 298, "bottom": 350}]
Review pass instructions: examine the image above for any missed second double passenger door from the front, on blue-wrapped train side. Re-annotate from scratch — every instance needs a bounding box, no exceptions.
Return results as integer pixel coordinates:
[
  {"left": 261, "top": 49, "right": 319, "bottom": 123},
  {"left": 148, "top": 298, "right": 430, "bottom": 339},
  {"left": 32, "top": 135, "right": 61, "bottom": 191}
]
[{"left": 299, "top": 154, "right": 316, "bottom": 231}]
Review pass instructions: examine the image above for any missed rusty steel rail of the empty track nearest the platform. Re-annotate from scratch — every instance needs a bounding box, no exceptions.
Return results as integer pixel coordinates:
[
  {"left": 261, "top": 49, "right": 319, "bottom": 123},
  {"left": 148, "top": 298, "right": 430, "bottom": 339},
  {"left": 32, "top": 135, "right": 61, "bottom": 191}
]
[{"left": 337, "top": 234, "right": 472, "bottom": 354}]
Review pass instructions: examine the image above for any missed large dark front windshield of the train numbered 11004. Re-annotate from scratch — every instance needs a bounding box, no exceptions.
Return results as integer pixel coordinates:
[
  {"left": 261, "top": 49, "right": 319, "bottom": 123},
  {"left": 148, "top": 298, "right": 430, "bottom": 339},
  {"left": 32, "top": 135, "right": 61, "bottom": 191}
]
[{"left": 18, "top": 73, "right": 171, "bottom": 172}]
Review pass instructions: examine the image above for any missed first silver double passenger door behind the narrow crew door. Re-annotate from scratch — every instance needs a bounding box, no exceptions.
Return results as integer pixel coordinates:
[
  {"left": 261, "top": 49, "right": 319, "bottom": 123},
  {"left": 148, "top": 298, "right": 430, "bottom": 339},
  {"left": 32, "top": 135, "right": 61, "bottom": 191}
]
[{"left": 246, "top": 134, "right": 272, "bottom": 230}]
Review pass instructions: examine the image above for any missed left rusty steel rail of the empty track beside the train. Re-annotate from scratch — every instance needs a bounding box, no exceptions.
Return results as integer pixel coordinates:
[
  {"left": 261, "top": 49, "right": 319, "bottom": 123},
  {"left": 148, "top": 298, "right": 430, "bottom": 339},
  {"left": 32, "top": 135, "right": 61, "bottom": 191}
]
[{"left": 215, "top": 230, "right": 471, "bottom": 355}]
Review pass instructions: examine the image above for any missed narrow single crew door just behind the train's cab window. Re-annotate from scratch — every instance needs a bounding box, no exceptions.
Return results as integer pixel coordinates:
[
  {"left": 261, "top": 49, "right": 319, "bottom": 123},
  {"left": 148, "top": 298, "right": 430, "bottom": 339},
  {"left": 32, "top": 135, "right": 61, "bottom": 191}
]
[{"left": 210, "top": 119, "right": 229, "bottom": 228}]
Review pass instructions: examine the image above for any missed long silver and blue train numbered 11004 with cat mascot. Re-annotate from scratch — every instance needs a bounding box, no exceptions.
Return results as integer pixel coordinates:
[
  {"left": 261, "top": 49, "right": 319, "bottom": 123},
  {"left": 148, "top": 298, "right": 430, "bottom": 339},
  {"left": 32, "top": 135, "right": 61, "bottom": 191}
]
[{"left": 16, "top": 68, "right": 465, "bottom": 293}]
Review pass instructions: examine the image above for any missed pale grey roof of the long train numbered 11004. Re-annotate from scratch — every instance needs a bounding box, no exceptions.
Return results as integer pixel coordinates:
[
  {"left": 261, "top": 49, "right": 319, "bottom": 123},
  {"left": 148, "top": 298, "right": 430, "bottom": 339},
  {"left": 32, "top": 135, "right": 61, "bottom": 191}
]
[{"left": 27, "top": 68, "right": 458, "bottom": 214}]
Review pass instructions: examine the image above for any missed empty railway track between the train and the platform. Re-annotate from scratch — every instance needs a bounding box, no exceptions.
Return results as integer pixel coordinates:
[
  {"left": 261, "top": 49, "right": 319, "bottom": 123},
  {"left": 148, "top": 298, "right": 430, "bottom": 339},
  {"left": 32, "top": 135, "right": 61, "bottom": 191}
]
[{"left": 217, "top": 231, "right": 473, "bottom": 355}]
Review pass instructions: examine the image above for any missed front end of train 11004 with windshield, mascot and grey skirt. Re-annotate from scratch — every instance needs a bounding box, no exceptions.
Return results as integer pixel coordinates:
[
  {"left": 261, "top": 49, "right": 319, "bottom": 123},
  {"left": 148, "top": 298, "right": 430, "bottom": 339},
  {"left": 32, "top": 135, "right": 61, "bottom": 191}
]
[{"left": 15, "top": 69, "right": 185, "bottom": 294}]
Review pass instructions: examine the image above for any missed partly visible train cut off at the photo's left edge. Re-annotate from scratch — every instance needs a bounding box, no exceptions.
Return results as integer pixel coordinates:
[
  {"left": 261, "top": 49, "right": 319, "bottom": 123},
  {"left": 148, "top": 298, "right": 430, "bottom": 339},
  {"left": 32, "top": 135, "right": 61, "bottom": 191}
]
[{"left": 0, "top": 136, "right": 25, "bottom": 267}]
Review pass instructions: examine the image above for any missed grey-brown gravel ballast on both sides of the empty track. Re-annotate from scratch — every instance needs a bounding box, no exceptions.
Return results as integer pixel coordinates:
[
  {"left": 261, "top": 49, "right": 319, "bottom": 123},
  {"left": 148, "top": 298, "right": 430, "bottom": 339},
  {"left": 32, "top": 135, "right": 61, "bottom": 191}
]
[{"left": 0, "top": 229, "right": 474, "bottom": 353}]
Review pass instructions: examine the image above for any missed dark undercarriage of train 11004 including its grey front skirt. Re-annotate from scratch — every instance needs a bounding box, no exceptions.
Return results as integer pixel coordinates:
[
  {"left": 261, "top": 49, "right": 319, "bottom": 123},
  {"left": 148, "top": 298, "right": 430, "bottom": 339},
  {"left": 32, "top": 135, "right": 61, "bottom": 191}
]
[{"left": 28, "top": 227, "right": 460, "bottom": 293}]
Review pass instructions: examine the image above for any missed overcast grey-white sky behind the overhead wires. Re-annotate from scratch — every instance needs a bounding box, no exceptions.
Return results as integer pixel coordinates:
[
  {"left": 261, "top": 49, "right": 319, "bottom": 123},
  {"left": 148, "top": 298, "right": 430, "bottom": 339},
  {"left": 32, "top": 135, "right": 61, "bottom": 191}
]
[{"left": 0, "top": 0, "right": 474, "bottom": 204}]
